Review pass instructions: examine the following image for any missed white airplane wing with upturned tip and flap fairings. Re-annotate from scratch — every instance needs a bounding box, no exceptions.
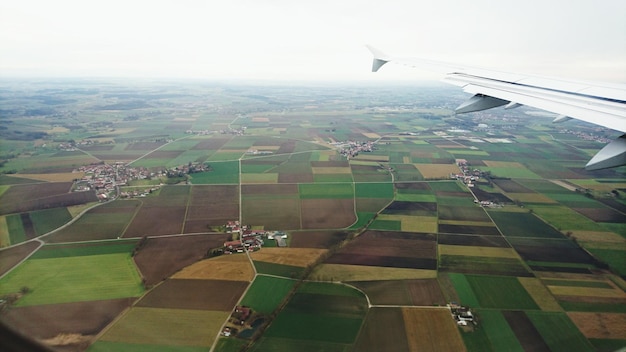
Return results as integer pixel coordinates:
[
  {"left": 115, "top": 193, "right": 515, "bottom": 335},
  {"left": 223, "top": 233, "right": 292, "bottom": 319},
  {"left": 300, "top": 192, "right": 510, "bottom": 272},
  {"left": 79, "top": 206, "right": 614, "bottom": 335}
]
[{"left": 368, "top": 46, "right": 626, "bottom": 170}]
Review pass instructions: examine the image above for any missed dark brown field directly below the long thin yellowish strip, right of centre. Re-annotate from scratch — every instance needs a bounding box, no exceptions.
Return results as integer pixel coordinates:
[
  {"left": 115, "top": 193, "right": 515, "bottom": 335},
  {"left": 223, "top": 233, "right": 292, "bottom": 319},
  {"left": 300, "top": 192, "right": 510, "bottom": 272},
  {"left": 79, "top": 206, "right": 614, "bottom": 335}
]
[{"left": 350, "top": 279, "right": 446, "bottom": 306}]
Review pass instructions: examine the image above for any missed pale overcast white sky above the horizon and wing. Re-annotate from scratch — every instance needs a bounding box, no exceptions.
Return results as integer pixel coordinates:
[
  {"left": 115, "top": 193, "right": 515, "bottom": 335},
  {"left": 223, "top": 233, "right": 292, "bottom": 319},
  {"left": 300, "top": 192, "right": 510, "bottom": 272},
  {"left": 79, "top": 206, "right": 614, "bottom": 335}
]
[{"left": 0, "top": 0, "right": 626, "bottom": 83}]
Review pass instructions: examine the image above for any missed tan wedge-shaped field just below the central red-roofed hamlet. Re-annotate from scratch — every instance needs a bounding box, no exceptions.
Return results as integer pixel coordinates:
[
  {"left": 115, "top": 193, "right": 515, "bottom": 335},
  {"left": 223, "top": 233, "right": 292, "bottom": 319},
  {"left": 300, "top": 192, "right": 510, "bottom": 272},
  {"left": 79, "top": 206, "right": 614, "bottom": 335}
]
[{"left": 172, "top": 254, "right": 254, "bottom": 281}]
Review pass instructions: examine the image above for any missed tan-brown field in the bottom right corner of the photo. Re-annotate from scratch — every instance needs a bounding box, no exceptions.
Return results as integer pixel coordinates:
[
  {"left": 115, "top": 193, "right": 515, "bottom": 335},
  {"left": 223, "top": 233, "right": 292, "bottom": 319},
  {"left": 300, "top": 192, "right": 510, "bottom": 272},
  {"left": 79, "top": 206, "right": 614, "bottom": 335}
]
[{"left": 567, "top": 312, "right": 626, "bottom": 340}]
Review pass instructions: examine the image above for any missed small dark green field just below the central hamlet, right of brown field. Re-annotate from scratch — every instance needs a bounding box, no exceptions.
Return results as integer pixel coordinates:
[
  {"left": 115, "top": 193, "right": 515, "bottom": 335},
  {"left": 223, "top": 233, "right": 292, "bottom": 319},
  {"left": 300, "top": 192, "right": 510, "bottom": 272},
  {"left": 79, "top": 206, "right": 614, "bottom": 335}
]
[{"left": 241, "top": 275, "right": 296, "bottom": 314}]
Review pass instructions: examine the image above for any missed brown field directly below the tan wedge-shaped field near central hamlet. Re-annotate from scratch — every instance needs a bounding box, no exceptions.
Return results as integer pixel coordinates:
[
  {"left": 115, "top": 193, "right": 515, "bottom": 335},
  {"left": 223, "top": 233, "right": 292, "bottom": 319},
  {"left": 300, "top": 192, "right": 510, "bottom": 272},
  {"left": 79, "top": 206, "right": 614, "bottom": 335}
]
[{"left": 136, "top": 279, "right": 249, "bottom": 311}]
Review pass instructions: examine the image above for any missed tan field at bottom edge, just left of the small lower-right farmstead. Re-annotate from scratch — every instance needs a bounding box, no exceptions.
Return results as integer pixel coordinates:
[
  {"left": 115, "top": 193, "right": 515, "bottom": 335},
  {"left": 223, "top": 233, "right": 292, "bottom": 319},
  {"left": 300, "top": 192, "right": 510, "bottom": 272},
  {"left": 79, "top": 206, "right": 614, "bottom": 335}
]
[{"left": 402, "top": 308, "right": 467, "bottom": 351}]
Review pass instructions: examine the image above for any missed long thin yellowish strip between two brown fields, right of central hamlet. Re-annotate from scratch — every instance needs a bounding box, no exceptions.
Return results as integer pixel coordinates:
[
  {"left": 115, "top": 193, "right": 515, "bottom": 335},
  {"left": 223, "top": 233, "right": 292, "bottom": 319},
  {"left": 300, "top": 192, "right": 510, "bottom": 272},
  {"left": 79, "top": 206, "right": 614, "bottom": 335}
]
[{"left": 311, "top": 264, "right": 437, "bottom": 281}]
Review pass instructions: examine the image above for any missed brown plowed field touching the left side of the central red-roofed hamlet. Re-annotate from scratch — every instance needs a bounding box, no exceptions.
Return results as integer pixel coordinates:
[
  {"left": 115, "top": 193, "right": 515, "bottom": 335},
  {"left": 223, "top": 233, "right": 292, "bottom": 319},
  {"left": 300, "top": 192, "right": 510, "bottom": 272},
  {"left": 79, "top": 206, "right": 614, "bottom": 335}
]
[{"left": 133, "top": 234, "right": 229, "bottom": 285}]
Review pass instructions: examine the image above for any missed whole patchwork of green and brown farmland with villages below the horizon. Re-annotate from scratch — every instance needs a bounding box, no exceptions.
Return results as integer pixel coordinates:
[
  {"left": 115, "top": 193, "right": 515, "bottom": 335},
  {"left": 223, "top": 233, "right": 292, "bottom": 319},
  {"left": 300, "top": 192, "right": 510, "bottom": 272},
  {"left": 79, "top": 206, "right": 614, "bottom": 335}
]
[{"left": 0, "top": 83, "right": 626, "bottom": 352}]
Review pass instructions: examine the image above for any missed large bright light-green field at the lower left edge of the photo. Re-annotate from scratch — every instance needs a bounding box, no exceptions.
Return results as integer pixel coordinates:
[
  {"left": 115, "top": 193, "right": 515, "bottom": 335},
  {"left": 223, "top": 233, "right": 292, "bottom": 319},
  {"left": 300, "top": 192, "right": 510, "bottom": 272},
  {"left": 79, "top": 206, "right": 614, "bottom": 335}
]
[{"left": 0, "top": 253, "right": 144, "bottom": 306}]
